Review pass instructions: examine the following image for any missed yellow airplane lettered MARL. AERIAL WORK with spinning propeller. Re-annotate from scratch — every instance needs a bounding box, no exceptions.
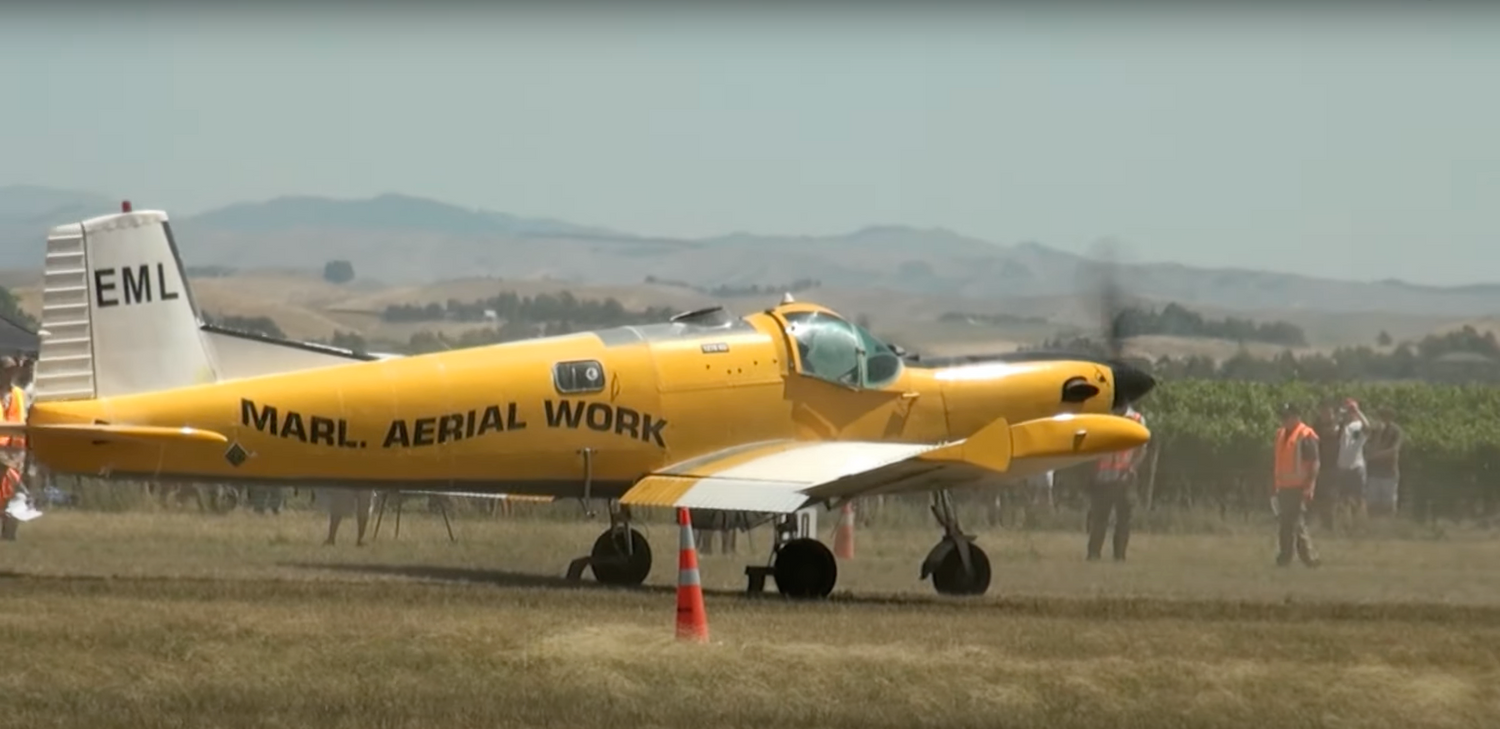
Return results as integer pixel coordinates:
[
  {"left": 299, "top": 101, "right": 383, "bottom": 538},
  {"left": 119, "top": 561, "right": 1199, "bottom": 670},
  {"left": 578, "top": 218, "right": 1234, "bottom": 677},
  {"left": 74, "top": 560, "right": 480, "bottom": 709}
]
[{"left": 11, "top": 210, "right": 1155, "bottom": 597}]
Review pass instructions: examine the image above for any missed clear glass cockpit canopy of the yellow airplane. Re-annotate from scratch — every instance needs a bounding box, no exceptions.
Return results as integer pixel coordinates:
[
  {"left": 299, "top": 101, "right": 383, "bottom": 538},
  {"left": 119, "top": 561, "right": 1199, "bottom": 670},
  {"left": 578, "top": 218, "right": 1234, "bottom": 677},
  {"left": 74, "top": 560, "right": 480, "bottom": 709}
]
[{"left": 782, "top": 311, "right": 902, "bottom": 389}]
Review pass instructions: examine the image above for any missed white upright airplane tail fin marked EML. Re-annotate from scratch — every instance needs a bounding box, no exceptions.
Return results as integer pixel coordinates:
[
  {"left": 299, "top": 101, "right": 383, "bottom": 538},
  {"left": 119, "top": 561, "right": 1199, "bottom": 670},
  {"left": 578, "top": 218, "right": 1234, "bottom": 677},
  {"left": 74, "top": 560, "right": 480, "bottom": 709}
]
[{"left": 35, "top": 204, "right": 219, "bottom": 402}]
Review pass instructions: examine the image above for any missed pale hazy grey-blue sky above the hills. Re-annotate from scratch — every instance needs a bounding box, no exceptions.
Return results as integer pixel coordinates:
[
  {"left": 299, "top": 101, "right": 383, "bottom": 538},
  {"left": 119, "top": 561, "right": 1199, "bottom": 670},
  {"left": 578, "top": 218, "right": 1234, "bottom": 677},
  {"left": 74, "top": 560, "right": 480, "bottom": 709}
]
[{"left": 0, "top": 3, "right": 1500, "bottom": 284}]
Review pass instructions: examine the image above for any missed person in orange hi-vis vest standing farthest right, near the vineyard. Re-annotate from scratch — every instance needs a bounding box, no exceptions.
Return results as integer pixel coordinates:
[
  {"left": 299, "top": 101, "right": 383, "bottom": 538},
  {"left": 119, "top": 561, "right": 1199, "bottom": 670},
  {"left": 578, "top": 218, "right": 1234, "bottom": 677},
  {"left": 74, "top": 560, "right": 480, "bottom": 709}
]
[{"left": 1272, "top": 402, "right": 1322, "bottom": 567}]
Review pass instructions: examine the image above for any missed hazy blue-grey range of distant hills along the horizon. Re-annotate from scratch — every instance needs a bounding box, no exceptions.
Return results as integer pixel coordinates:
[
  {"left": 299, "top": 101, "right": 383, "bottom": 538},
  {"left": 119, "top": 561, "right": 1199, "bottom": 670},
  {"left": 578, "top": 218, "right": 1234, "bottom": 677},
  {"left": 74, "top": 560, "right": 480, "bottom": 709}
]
[{"left": 0, "top": 188, "right": 1500, "bottom": 327}]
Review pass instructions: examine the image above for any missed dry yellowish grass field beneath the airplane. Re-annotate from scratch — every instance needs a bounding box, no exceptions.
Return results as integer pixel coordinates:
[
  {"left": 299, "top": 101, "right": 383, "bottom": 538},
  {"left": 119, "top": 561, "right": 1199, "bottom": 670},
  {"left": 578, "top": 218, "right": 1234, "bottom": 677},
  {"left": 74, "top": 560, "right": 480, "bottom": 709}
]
[{"left": 0, "top": 507, "right": 1500, "bottom": 729}]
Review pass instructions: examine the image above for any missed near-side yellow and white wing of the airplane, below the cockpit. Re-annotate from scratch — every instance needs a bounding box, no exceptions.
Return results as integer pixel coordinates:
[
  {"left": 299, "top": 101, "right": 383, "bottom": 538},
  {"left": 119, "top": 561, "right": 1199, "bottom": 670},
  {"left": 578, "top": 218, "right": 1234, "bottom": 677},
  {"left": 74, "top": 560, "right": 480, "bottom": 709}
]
[{"left": 620, "top": 414, "right": 1151, "bottom": 513}]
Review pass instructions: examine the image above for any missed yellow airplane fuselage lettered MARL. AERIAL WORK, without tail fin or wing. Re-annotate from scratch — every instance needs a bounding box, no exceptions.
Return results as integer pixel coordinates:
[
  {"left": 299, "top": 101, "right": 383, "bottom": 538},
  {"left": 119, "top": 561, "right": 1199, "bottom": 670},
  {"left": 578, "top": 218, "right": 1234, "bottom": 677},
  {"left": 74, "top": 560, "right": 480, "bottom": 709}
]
[{"left": 32, "top": 301, "right": 1110, "bottom": 498}]
